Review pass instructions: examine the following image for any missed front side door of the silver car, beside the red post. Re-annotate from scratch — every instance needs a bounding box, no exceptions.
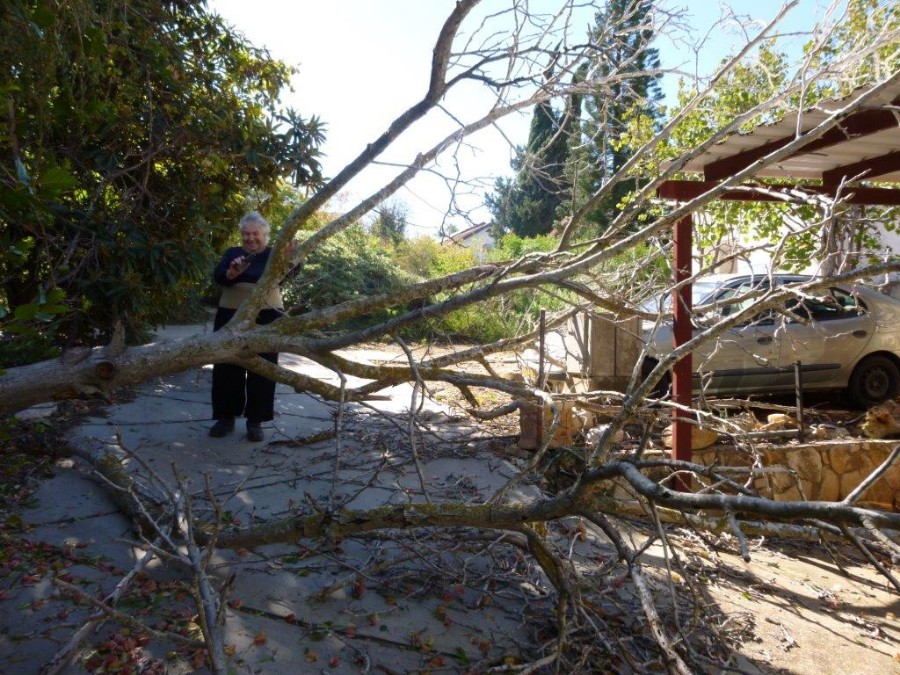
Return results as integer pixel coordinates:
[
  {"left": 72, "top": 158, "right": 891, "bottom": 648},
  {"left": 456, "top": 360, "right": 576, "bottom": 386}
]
[{"left": 694, "top": 280, "right": 780, "bottom": 393}]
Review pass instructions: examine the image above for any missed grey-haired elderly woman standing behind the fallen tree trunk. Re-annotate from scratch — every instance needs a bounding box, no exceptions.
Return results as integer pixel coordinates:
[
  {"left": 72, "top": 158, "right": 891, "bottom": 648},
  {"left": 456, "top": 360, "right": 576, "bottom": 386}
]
[{"left": 209, "top": 211, "right": 284, "bottom": 443}]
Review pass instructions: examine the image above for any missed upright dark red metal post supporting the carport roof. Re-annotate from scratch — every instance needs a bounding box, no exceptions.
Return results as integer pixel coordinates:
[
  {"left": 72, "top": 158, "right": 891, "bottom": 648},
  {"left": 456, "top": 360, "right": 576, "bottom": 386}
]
[{"left": 672, "top": 214, "right": 693, "bottom": 490}]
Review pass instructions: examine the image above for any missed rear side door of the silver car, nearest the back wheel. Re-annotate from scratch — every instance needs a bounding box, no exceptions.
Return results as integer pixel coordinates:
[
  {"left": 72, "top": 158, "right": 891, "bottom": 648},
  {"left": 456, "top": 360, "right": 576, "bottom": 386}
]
[{"left": 777, "top": 287, "right": 875, "bottom": 387}]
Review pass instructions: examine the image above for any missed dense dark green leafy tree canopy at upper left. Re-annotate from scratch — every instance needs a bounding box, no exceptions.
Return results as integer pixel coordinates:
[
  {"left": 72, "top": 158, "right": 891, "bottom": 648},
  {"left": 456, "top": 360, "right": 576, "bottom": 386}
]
[{"left": 0, "top": 0, "right": 324, "bottom": 359}]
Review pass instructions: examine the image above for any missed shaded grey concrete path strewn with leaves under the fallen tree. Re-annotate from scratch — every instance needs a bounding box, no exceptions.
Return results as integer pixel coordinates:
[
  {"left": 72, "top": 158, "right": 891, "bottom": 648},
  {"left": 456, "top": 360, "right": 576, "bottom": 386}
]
[{"left": 0, "top": 326, "right": 552, "bottom": 674}]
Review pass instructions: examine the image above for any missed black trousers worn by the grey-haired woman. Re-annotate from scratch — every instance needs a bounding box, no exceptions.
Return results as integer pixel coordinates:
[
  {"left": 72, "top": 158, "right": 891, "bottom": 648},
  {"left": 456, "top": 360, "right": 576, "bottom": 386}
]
[{"left": 212, "top": 307, "right": 281, "bottom": 423}]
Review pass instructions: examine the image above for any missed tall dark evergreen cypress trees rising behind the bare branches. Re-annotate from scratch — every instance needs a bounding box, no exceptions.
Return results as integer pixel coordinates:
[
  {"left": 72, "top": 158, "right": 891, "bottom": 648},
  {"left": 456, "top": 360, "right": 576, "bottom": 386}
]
[{"left": 487, "top": 0, "right": 663, "bottom": 238}]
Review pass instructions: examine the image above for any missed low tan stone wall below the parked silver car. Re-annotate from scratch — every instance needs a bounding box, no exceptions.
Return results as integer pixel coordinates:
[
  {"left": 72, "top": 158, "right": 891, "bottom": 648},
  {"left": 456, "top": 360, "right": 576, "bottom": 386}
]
[{"left": 694, "top": 439, "right": 900, "bottom": 511}]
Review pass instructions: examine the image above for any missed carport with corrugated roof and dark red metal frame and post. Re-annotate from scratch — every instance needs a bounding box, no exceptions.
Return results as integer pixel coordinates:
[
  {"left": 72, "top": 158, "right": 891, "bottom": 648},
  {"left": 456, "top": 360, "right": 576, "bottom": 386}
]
[{"left": 657, "top": 74, "right": 900, "bottom": 470}]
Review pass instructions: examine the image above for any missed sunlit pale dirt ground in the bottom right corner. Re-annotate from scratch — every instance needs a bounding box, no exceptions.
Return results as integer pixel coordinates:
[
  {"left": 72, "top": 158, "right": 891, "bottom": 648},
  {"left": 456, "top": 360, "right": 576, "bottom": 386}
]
[{"left": 709, "top": 543, "right": 900, "bottom": 675}]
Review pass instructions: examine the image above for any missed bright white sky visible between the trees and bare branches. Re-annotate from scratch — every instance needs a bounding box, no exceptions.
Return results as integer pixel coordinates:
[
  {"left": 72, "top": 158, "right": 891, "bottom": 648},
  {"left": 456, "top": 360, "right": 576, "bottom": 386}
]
[{"left": 208, "top": 0, "right": 840, "bottom": 236}]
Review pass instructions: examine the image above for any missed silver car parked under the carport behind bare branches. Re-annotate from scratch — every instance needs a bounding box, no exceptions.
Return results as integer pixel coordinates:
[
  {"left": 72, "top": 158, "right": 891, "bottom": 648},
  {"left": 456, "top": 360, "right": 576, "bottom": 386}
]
[{"left": 644, "top": 274, "right": 900, "bottom": 408}]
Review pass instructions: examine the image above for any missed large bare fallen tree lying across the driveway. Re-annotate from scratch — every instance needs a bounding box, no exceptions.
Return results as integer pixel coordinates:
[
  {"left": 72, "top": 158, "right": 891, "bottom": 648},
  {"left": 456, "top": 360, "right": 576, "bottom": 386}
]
[{"left": 0, "top": 0, "right": 900, "bottom": 673}]
